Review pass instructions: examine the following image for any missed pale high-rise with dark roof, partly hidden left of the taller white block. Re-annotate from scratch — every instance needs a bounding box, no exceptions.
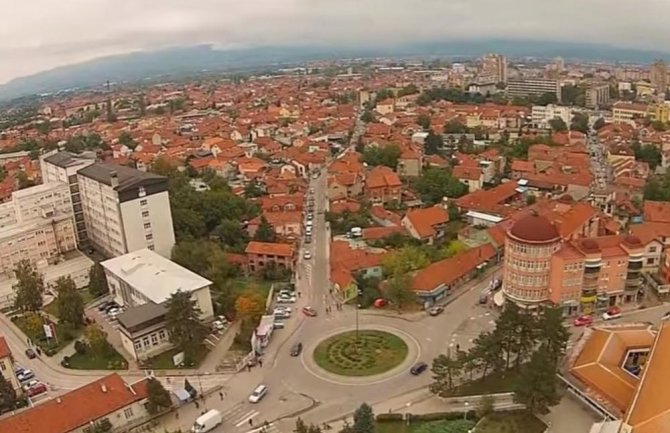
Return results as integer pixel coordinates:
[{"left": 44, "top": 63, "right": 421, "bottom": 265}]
[{"left": 40, "top": 152, "right": 95, "bottom": 245}]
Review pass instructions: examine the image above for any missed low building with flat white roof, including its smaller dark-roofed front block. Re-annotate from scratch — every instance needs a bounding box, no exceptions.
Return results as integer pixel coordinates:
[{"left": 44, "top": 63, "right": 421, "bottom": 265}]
[{"left": 101, "top": 248, "right": 214, "bottom": 359}]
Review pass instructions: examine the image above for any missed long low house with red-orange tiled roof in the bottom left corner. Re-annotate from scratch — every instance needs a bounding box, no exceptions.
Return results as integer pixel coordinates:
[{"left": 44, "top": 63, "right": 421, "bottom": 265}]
[{"left": 0, "top": 373, "right": 149, "bottom": 433}]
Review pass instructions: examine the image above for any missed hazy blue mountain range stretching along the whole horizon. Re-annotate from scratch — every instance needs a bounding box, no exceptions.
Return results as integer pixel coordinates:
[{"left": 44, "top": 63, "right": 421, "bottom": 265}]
[{"left": 0, "top": 40, "right": 670, "bottom": 100}]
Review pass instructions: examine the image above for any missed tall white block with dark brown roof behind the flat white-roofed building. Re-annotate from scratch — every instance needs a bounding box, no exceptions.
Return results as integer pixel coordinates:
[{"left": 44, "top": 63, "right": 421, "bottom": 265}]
[{"left": 77, "top": 163, "right": 175, "bottom": 257}]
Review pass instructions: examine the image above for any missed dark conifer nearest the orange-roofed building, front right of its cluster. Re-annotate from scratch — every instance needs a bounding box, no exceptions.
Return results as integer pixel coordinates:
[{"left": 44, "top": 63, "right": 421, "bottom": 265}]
[{"left": 514, "top": 350, "right": 560, "bottom": 414}]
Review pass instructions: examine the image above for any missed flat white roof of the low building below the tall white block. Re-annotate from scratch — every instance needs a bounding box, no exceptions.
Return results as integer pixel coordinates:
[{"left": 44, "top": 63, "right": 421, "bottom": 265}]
[{"left": 101, "top": 248, "right": 212, "bottom": 304}]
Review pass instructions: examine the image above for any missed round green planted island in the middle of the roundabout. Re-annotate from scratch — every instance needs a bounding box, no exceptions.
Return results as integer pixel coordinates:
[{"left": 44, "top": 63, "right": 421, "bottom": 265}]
[{"left": 313, "top": 329, "right": 409, "bottom": 377}]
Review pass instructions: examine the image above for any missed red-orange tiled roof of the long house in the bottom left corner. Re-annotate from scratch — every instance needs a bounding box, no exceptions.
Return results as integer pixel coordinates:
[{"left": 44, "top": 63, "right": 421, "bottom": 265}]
[{"left": 0, "top": 373, "right": 147, "bottom": 433}]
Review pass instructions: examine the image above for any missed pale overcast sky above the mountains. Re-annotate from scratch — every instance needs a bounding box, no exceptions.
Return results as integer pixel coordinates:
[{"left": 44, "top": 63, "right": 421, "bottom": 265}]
[{"left": 0, "top": 0, "right": 670, "bottom": 83}]
